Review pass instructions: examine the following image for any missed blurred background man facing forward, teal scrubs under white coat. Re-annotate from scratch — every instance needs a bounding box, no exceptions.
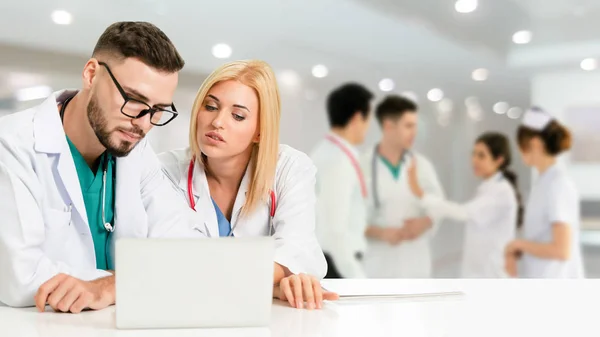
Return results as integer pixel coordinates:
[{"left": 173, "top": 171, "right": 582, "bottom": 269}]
[{"left": 362, "top": 96, "right": 443, "bottom": 278}]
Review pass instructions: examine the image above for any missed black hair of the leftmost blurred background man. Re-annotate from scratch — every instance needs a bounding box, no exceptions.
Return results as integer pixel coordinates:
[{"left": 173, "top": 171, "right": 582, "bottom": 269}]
[{"left": 327, "top": 83, "right": 373, "bottom": 127}]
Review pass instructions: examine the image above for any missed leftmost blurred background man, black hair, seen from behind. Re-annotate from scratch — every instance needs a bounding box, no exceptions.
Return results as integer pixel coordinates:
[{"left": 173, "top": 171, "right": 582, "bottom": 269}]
[{"left": 311, "top": 83, "right": 373, "bottom": 278}]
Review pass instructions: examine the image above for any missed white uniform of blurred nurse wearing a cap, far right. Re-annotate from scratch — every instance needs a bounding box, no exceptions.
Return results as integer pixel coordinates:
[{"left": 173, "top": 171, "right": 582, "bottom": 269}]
[{"left": 519, "top": 164, "right": 584, "bottom": 278}]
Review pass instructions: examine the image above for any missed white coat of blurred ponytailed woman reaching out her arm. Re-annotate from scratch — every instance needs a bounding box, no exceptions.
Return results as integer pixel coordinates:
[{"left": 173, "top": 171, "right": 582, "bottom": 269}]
[{"left": 422, "top": 173, "right": 518, "bottom": 278}]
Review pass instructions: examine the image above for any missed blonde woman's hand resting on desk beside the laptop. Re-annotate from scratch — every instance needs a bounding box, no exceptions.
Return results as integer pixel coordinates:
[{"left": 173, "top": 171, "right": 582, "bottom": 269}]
[{"left": 273, "top": 274, "right": 339, "bottom": 310}]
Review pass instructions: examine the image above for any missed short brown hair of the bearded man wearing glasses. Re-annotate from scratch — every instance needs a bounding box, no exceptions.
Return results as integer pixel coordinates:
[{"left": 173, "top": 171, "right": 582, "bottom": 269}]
[{"left": 92, "top": 21, "right": 185, "bottom": 73}]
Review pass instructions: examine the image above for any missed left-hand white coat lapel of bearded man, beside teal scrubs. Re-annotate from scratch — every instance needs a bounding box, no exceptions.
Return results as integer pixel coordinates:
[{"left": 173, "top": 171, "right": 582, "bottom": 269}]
[{"left": 33, "top": 90, "right": 90, "bottom": 235}]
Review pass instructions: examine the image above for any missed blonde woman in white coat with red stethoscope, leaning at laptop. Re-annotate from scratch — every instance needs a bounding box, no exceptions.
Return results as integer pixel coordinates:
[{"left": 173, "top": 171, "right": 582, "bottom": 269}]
[{"left": 159, "top": 60, "right": 335, "bottom": 309}]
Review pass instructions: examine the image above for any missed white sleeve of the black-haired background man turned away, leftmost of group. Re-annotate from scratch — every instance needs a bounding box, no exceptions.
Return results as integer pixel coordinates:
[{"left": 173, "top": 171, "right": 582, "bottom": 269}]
[{"left": 318, "top": 161, "right": 366, "bottom": 278}]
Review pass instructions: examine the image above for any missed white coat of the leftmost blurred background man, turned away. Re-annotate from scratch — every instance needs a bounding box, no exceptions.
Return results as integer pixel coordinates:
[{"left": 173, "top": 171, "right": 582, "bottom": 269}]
[{"left": 310, "top": 133, "right": 367, "bottom": 278}]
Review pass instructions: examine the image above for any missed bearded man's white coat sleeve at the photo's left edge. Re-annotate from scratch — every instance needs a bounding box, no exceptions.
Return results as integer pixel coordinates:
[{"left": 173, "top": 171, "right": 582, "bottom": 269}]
[{"left": 0, "top": 159, "right": 111, "bottom": 307}]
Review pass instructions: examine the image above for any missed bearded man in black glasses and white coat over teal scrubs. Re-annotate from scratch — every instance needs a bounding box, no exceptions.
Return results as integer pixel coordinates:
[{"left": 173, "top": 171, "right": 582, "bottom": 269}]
[{"left": 0, "top": 22, "right": 203, "bottom": 312}]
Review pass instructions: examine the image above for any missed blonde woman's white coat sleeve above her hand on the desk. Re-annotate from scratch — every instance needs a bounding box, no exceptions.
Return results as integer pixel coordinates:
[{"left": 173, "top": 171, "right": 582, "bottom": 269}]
[{"left": 273, "top": 154, "right": 327, "bottom": 279}]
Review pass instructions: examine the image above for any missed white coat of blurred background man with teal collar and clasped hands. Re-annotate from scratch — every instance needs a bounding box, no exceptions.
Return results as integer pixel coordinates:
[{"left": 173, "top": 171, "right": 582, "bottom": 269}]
[{"left": 362, "top": 149, "right": 444, "bottom": 278}]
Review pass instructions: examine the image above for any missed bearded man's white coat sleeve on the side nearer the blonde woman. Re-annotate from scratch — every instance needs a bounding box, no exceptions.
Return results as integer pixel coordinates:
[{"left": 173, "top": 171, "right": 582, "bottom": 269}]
[{"left": 140, "top": 142, "right": 208, "bottom": 238}]
